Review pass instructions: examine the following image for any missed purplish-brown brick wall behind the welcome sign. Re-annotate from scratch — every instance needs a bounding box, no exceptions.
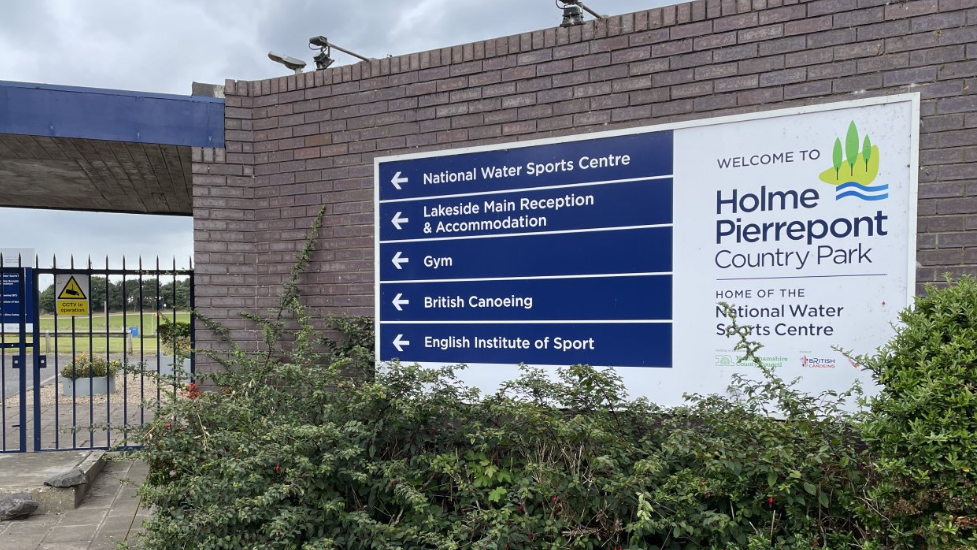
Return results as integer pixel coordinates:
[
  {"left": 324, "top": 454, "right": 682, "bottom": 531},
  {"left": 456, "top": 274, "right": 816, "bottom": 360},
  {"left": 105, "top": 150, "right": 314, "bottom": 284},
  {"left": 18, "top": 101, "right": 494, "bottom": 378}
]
[{"left": 194, "top": 0, "right": 977, "bottom": 356}]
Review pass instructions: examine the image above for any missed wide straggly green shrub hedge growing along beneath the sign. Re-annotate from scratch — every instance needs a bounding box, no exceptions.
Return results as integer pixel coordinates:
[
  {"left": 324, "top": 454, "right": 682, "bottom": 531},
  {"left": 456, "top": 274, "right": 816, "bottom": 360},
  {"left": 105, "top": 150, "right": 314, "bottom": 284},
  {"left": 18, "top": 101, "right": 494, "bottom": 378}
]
[{"left": 132, "top": 308, "right": 864, "bottom": 550}]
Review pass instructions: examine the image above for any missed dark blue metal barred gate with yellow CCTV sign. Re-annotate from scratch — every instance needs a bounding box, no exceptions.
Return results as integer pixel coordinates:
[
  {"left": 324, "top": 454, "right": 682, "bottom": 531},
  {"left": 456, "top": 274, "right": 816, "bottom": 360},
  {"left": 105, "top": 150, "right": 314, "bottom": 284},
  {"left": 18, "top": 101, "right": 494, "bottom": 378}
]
[{"left": 0, "top": 257, "right": 195, "bottom": 453}]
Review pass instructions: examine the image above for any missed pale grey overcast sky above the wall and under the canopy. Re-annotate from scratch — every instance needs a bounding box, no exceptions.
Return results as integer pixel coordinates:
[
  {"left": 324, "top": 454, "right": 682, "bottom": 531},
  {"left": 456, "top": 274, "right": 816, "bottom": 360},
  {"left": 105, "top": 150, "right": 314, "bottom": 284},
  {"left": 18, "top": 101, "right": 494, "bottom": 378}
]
[{"left": 0, "top": 0, "right": 670, "bottom": 265}]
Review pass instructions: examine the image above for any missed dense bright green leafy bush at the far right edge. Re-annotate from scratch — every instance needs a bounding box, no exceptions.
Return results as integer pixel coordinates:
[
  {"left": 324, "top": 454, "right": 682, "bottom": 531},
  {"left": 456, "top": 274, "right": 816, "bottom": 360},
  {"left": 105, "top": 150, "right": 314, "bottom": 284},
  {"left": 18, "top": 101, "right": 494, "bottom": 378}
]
[{"left": 861, "top": 278, "right": 977, "bottom": 549}]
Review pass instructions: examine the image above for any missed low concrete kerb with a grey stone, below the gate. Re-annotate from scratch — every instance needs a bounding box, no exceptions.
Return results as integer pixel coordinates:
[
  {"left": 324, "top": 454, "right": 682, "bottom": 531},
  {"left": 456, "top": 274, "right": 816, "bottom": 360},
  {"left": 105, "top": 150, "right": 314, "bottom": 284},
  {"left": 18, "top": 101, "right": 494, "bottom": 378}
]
[{"left": 0, "top": 451, "right": 105, "bottom": 514}]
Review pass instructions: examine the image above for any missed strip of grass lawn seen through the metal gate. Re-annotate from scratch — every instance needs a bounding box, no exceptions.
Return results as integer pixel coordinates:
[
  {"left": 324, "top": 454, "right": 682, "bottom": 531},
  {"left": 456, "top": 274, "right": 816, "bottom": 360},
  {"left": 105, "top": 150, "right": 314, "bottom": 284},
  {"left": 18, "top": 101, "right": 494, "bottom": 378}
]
[{"left": 3, "top": 310, "right": 190, "bottom": 360}]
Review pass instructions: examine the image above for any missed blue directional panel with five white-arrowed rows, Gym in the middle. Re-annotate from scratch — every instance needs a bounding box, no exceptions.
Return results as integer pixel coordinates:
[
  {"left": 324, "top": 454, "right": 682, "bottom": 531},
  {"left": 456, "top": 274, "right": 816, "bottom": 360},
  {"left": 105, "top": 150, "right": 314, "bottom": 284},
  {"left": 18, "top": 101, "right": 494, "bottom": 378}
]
[{"left": 375, "top": 131, "right": 675, "bottom": 368}]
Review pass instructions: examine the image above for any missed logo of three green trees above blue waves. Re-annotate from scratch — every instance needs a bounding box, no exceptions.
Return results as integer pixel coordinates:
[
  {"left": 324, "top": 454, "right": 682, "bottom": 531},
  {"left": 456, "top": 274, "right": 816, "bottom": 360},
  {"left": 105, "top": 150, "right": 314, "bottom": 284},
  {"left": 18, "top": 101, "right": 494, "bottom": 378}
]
[{"left": 818, "top": 121, "right": 889, "bottom": 201}]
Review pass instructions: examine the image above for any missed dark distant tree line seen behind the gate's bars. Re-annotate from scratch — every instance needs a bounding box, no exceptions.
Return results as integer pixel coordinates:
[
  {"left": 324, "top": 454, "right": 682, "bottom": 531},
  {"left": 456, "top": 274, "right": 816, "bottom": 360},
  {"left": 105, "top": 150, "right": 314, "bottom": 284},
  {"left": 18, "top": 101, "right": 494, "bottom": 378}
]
[{"left": 38, "top": 277, "right": 190, "bottom": 313}]
